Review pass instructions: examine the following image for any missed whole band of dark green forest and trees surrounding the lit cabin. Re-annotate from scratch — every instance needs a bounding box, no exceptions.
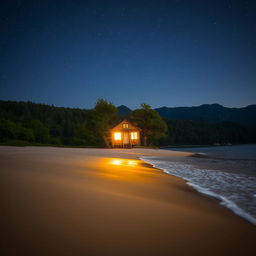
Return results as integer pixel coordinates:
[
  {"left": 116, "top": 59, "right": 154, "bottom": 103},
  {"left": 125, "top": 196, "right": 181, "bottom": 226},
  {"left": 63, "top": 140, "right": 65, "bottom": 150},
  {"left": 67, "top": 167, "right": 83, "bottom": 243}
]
[{"left": 0, "top": 100, "right": 256, "bottom": 147}]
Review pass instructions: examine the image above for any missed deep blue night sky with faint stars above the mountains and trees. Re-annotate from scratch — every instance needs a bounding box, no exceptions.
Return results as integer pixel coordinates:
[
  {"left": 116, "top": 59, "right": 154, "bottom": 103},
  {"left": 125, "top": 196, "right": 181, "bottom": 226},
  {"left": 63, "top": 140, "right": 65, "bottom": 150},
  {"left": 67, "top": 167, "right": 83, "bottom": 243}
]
[{"left": 0, "top": 0, "right": 256, "bottom": 108}]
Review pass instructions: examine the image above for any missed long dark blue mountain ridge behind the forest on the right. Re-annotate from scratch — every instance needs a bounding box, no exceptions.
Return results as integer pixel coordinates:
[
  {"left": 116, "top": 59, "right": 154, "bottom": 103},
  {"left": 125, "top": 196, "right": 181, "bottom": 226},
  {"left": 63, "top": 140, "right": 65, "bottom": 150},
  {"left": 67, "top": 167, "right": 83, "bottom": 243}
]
[{"left": 155, "top": 104, "right": 256, "bottom": 127}]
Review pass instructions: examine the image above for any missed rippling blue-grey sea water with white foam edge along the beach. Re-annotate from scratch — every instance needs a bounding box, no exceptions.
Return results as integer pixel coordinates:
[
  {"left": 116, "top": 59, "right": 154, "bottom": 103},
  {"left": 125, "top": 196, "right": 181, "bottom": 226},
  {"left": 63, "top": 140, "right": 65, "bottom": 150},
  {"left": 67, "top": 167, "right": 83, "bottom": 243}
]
[{"left": 141, "top": 145, "right": 256, "bottom": 225}]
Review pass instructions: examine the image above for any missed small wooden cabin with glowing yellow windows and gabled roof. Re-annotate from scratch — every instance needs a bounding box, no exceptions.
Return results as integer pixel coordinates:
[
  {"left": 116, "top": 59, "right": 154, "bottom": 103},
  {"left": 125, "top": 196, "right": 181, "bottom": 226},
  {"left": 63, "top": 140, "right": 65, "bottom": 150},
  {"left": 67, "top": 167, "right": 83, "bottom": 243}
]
[{"left": 110, "top": 120, "right": 140, "bottom": 147}]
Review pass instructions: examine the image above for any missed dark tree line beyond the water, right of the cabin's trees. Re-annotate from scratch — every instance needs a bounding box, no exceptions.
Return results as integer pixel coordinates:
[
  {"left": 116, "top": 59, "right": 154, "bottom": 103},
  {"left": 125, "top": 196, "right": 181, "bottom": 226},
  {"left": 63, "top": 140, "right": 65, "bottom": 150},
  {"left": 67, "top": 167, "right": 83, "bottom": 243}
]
[{"left": 159, "top": 119, "right": 256, "bottom": 146}]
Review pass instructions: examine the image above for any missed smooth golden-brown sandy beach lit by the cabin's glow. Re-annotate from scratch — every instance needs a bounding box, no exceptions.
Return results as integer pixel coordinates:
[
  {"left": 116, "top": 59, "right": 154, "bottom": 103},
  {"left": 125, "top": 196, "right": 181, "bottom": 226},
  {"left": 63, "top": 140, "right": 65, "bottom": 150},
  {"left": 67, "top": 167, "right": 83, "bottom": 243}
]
[{"left": 0, "top": 147, "right": 256, "bottom": 256}]
